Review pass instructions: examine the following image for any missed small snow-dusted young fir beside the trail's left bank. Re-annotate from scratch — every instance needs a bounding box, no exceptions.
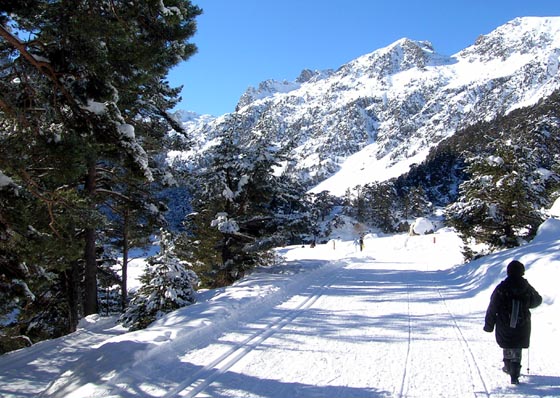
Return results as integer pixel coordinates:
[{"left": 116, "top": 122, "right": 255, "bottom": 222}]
[{"left": 120, "top": 232, "right": 199, "bottom": 330}]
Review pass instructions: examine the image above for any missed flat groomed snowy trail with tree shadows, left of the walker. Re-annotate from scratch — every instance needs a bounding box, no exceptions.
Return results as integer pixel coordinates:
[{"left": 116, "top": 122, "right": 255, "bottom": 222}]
[{"left": 155, "top": 258, "right": 490, "bottom": 397}]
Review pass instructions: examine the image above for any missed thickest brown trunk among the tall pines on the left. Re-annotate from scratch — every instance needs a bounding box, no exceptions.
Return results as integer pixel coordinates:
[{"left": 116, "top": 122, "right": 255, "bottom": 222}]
[{"left": 84, "top": 159, "right": 97, "bottom": 316}]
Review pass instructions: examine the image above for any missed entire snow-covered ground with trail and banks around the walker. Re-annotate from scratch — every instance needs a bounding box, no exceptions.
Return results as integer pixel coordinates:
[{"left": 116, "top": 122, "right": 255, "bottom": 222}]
[{"left": 0, "top": 218, "right": 560, "bottom": 398}]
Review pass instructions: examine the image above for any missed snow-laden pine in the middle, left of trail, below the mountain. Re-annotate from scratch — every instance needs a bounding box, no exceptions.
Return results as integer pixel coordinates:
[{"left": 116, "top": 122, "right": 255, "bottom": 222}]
[{"left": 184, "top": 116, "right": 304, "bottom": 287}]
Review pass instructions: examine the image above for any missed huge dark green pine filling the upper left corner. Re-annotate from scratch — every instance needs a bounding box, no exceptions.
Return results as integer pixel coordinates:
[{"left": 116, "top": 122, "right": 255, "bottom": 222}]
[{"left": 0, "top": 0, "right": 201, "bottom": 338}]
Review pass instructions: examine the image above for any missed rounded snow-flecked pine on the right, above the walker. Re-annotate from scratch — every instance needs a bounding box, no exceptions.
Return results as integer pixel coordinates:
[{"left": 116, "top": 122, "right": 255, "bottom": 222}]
[{"left": 446, "top": 145, "right": 542, "bottom": 247}]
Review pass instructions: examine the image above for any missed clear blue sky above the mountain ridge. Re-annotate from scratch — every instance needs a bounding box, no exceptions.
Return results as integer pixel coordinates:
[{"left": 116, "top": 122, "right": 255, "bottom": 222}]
[{"left": 169, "top": 0, "right": 560, "bottom": 116}]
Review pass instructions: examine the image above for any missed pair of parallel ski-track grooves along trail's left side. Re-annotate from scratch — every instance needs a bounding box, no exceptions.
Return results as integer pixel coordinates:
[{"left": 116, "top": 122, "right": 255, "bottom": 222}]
[{"left": 164, "top": 262, "right": 350, "bottom": 398}]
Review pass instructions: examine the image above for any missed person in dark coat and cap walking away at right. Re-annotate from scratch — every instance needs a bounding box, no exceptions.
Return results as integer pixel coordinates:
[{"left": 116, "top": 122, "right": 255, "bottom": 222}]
[{"left": 484, "top": 260, "right": 542, "bottom": 384}]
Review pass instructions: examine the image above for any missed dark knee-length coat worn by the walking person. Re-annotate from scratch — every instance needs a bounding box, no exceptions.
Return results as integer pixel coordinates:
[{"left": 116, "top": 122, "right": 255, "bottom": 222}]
[{"left": 484, "top": 275, "right": 542, "bottom": 348}]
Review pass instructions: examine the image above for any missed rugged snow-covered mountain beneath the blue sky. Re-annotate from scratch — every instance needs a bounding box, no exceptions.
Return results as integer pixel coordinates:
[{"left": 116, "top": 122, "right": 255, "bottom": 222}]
[{"left": 177, "top": 17, "right": 560, "bottom": 195}]
